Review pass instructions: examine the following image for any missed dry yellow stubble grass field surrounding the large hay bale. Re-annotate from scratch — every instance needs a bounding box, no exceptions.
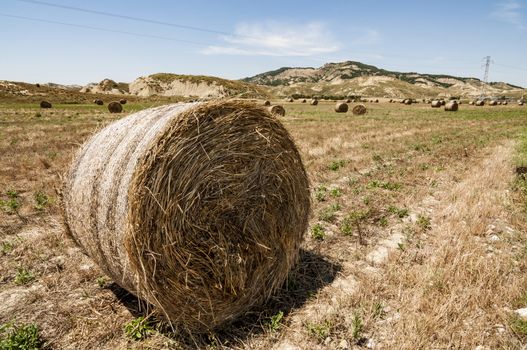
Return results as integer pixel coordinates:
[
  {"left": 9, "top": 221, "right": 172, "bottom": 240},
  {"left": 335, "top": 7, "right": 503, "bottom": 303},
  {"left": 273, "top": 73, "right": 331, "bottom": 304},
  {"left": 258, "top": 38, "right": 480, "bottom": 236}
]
[{"left": 0, "top": 101, "right": 527, "bottom": 349}]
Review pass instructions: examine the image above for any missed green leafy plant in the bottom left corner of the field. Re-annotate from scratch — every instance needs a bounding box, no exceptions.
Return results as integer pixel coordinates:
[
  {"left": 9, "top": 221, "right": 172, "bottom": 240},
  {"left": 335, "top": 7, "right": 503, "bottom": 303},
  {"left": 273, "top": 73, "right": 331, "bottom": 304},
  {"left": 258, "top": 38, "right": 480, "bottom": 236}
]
[{"left": 0, "top": 323, "right": 44, "bottom": 350}]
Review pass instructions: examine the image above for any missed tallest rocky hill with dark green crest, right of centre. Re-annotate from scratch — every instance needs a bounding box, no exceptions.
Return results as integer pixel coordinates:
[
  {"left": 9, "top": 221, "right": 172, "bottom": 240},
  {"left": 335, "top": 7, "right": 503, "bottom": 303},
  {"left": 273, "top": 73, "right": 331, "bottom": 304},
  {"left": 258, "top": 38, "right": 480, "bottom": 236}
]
[{"left": 243, "top": 61, "right": 526, "bottom": 98}]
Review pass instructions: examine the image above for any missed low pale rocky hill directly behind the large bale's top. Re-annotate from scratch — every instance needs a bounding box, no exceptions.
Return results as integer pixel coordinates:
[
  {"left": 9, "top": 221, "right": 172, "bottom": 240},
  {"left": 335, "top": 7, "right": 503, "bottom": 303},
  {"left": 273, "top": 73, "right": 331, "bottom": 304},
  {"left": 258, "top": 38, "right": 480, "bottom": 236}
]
[{"left": 129, "top": 73, "right": 267, "bottom": 98}]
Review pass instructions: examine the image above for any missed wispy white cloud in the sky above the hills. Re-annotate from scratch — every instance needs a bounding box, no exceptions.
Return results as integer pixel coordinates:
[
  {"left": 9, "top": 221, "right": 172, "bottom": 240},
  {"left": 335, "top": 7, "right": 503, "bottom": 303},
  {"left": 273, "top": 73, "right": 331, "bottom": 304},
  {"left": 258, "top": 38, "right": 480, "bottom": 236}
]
[{"left": 201, "top": 21, "right": 340, "bottom": 56}]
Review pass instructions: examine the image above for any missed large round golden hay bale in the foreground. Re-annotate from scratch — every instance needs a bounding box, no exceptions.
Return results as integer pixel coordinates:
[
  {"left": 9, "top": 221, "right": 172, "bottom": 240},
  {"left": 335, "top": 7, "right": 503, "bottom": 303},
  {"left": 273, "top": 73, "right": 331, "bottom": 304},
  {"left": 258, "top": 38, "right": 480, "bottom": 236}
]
[{"left": 63, "top": 101, "right": 310, "bottom": 332}]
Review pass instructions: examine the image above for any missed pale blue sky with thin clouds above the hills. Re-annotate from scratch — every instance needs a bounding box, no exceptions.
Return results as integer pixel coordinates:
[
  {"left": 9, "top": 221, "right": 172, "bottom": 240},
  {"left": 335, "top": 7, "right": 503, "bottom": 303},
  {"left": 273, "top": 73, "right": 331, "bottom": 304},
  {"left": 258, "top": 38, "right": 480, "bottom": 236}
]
[{"left": 0, "top": 0, "right": 527, "bottom": 87}]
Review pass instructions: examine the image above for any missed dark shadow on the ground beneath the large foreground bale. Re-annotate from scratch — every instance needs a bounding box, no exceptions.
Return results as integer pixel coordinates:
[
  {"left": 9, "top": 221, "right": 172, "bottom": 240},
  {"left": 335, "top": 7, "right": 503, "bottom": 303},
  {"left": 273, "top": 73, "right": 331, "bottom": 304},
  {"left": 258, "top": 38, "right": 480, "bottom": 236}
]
[{"left": 106, "top": 249, "right": 342, "bottom": 348}]
